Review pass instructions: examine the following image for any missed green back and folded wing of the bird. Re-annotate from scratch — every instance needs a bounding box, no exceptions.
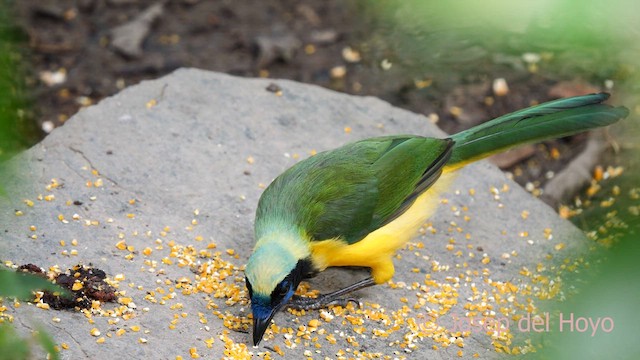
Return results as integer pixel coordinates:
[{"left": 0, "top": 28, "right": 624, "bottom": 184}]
[{"left": 256, "top": 135, "right": 453, "bottom": 243}]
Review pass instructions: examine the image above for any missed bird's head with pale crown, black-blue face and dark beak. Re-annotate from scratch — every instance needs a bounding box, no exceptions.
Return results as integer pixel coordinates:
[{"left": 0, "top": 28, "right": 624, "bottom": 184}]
[{"left": 245, "top": 239, "right": 311, "bottom": 345}]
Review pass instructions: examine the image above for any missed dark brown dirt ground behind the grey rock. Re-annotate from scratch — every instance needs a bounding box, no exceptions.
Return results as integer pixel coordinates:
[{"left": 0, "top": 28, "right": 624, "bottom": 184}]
[{"left": 15, "top": 0, "right": 596, "bottom": 194}]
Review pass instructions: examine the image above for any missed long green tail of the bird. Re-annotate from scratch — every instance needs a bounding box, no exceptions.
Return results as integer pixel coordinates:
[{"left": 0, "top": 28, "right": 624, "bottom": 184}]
[{"left": 447, "top": 93, "right": 629, "bottom": 168}]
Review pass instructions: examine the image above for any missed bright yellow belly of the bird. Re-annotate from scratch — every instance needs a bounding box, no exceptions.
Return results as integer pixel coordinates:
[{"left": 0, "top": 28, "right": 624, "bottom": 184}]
[{"left": 311, "top": 169, "right": 455, "bottom": 284}]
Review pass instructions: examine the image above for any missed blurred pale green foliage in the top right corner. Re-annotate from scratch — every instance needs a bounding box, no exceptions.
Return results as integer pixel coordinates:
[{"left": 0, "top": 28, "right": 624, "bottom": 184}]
[{"left": 356, "top": 0, "right": 640, "bottom": 88}]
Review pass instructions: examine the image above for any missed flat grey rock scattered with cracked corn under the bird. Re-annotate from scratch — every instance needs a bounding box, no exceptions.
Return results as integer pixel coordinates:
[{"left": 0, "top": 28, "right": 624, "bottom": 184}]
[{"left": 0, "top": 69, "right": 586, "bottom": 359}]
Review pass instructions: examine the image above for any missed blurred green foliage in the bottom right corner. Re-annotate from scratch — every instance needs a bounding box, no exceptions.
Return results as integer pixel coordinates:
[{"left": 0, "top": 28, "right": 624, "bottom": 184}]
[{"left": 529, "top": 224, "right": 640, "bottom": 360}]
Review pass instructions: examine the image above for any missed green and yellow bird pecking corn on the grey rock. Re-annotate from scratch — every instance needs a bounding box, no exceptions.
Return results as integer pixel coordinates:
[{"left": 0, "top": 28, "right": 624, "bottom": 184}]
[{"left": 244, "top": 93, "right": 629, "bottom": 346}]
